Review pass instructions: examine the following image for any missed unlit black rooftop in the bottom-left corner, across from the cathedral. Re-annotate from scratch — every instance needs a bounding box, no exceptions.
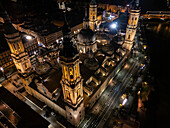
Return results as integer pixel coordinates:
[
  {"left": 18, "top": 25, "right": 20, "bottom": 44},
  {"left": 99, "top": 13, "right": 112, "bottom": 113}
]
[{"left": 0, "top": 87, "right": 50, "bottom": 128}]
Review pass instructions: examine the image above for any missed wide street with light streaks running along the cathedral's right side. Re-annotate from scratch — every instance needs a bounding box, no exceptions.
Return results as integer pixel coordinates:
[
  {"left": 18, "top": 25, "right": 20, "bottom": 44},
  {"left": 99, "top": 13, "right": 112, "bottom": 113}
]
[{"left": 79, "top": 58, "right": 140, "bottom": 128}]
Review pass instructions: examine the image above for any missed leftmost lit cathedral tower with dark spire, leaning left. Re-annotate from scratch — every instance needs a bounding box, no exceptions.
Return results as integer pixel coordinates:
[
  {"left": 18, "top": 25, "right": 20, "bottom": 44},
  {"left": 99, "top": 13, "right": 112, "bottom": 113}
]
[{"left": 4, "top": 12, "right": 33, "bottom": 89}]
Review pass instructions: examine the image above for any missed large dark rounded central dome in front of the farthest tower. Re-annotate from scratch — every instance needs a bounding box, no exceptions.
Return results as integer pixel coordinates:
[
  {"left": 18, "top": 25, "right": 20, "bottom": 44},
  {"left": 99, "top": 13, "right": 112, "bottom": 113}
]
[{"left": 77, "top": 28, "right": 96, "bottom": 43}]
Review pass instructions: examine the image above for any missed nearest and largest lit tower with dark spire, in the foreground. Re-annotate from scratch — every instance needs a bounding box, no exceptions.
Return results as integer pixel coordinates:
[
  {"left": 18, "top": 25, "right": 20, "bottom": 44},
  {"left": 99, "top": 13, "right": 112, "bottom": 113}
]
[{"left": 60, "top": 13, "right": 84, "bottom": 126}]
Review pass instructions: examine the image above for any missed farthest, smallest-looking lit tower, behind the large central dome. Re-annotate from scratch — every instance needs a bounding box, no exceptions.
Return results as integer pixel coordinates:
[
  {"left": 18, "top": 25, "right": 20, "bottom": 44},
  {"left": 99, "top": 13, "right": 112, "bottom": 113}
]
[{"left": 89, "top": 0, "right": 97, "bottom": 31}]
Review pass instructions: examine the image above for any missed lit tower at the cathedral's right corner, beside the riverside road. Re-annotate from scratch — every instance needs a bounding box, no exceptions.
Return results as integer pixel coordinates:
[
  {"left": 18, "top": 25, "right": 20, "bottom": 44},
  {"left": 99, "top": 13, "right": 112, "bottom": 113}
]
[{"left": 123, "top": 0, "right": 140, "bottom": 50}]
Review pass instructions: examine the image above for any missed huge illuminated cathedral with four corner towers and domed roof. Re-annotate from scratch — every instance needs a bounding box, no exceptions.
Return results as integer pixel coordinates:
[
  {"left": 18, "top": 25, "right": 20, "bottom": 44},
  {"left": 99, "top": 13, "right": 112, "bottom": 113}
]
[{"left": 5, "top": 0, "right": 140, "bottom": 126}]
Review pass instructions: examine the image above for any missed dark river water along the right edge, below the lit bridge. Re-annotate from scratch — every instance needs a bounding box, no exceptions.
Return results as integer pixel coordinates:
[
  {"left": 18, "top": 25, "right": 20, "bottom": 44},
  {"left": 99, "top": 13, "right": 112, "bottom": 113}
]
[{"left": 144, "top": 22, "right": 170, "bottom": 128}]
